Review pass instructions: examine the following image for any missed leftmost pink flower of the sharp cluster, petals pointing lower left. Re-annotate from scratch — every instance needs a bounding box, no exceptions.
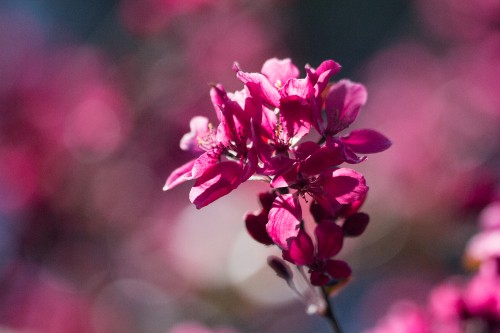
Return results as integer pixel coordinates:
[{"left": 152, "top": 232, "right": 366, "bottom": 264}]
[{"left": 164, "top": 86, "right": 257, "bottom": 208}]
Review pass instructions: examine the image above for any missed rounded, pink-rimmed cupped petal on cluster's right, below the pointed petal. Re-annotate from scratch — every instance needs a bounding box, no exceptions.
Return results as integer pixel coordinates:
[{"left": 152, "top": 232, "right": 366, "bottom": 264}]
[{"left": 322, "top": 168, "right": 368, "bottom": 204}]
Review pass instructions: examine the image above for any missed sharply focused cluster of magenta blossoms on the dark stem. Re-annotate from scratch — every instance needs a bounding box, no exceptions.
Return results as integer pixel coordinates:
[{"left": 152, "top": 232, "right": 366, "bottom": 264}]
[{"left": 164, "top": 58, "right": 391, "bottom": 286}]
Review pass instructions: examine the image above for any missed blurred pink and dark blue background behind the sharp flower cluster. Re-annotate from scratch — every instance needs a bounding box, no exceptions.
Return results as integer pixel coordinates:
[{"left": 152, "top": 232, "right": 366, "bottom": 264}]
[{"left": 0, "top": 0, "right": 500, "bottom": 333}]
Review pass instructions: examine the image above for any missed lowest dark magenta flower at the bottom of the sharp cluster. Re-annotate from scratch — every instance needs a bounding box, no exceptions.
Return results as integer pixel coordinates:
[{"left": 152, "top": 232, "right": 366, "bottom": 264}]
[{"left": 283, "top": 222, "right": 351, "bottom": 286}]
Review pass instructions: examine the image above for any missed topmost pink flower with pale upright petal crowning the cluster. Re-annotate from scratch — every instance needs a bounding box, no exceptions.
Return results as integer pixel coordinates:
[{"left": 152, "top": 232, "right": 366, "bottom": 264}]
[{"left": 234, "top": 58, "right": 346, "bottom": 174}]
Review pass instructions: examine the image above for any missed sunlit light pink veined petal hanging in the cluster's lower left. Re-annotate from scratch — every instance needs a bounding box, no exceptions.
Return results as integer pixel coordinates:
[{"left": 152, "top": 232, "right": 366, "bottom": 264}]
[{"left": 266, "top": 194, "right": 302, "bottom": 249}]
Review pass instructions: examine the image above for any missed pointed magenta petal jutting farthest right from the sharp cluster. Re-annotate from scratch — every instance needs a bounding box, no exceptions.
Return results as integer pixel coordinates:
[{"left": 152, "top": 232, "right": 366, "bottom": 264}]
[{"left": 340, "top": 129, "right": 392, "bottom": 154}]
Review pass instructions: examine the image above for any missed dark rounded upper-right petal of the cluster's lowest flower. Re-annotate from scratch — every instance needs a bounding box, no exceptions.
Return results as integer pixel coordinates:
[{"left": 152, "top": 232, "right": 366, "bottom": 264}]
[{"left": 314, "top": 221, "right": 344, "bottom": 259}]
